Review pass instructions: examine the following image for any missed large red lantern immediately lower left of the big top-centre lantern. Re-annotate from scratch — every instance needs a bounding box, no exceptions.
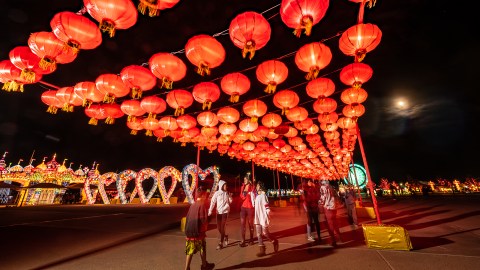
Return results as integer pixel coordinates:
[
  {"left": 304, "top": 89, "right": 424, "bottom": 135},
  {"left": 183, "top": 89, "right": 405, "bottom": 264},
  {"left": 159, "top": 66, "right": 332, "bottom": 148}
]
[{"left": 185, "top": 35, "right": 225, "bottom": 76}]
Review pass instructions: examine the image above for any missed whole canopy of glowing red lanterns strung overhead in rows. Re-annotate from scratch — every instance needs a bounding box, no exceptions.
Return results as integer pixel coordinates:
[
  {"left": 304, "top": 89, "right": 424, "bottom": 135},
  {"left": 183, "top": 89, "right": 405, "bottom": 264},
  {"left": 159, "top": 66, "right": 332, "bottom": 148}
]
[{"left": 0, "top": 0, "right": 382, "bottom": 179}]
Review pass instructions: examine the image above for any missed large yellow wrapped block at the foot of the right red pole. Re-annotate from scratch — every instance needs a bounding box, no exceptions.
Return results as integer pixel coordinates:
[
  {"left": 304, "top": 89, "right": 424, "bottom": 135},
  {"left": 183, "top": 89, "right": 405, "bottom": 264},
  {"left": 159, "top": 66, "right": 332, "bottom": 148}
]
[{"left": 362, "top": 224, "right": 412, "bottom": 250}]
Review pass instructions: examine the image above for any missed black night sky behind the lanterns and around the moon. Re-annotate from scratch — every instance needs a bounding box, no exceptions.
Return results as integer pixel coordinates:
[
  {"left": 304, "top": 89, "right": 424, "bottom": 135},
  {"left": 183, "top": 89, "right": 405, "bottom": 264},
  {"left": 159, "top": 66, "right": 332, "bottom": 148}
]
[{"left": 0, "top": 0, "right": 480, "bottom": 182}]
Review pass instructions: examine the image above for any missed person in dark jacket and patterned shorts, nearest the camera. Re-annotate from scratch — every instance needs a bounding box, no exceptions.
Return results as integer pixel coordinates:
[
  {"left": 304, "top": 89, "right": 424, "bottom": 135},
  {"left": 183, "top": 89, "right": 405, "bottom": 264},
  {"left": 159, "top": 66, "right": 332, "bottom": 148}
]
[{"left": 185, "top": 188, "right": 215, "bottom": 270}]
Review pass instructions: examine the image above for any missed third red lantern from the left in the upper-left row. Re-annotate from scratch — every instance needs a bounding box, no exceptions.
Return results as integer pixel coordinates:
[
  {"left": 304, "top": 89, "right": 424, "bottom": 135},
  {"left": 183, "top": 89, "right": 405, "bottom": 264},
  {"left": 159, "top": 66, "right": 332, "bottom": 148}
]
[{"left": 28, "top": 32, "right": 64, "bottom": 72}]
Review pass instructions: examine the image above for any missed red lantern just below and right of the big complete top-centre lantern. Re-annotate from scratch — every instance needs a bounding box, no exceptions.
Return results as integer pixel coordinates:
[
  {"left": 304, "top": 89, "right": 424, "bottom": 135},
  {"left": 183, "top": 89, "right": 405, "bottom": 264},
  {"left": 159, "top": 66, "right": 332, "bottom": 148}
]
[{"left": 256, "top": 60, "right": 288, "bottom": 94}]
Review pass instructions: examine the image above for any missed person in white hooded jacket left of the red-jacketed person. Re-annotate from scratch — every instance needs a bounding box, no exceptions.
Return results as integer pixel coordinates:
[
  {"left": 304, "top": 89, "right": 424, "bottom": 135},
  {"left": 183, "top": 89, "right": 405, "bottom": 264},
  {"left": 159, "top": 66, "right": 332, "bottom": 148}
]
[{"left": 208, "top": 180, "right": 232, "bottom": 250}]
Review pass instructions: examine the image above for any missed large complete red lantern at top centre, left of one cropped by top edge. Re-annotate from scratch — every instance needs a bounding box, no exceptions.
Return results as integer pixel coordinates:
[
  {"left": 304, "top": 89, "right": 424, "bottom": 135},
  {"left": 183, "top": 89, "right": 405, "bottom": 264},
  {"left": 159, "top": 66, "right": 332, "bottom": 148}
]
[{"left": 229, "top": 11, "right": 272, "bottom": 59}]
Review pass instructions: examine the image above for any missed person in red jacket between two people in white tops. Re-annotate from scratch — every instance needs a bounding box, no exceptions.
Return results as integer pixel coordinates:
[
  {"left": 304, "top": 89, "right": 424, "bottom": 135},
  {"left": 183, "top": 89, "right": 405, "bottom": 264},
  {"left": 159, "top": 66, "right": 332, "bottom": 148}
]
[{"left": 239, "top": 173, "right": 255, "bottom": 247}]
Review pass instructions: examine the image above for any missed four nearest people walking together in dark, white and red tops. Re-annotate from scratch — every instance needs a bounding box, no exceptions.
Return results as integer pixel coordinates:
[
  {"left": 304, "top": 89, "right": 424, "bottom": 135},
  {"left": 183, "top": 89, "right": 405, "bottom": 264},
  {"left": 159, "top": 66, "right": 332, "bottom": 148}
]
[{"left": 185, "top": 174, "right": 279, "bottom": 270}]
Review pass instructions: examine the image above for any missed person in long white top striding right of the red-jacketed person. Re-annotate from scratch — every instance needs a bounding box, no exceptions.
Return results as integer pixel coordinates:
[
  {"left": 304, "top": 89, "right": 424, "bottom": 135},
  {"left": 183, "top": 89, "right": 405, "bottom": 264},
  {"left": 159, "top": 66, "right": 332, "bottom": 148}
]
[{"left": 253, "top": 181, "right": 278, "bottom": 257}]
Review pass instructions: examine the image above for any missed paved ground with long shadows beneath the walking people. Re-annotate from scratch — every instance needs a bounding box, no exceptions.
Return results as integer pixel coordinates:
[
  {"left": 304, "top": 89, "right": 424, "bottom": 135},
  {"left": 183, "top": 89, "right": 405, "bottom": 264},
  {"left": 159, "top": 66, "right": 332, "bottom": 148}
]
[{"left": 0, "top": 196, "right": 480, "bottom": 270}]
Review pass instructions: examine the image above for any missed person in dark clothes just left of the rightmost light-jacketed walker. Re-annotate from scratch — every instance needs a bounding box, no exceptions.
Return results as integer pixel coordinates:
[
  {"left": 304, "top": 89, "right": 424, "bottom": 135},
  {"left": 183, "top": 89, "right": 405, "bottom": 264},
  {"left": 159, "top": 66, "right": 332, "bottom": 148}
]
[{"left": 303, "top": 179, "right": 322, "bottom": 242}]
